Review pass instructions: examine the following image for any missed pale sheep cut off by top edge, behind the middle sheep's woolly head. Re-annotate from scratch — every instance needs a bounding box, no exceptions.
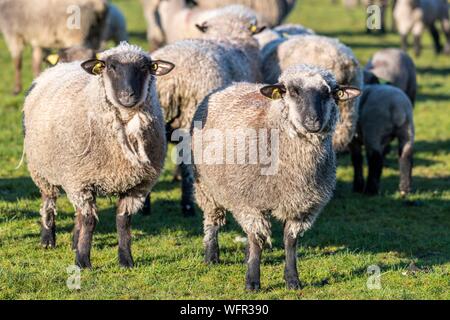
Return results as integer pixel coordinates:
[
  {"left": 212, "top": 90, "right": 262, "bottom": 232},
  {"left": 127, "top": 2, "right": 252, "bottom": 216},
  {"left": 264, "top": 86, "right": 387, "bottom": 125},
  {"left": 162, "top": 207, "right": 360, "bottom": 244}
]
[{"left": 141, "top": 0, "right": 296, "bottom": 48}]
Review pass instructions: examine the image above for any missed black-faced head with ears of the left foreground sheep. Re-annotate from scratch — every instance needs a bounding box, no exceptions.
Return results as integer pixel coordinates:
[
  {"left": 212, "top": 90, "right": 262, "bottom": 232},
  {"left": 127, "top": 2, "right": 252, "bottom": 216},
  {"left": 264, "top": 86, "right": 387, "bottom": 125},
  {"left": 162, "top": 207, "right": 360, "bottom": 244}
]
[{"left": 81, "top": 44, "right": 174, "bottom": 108}]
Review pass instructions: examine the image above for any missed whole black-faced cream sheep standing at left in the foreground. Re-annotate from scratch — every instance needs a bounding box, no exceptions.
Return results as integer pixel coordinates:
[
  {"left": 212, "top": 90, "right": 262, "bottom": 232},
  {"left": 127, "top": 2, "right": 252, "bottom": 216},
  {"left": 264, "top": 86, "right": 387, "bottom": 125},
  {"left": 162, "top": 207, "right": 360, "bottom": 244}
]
[{"left": 24, "top": 43, "right": 174, "bottom": 268}]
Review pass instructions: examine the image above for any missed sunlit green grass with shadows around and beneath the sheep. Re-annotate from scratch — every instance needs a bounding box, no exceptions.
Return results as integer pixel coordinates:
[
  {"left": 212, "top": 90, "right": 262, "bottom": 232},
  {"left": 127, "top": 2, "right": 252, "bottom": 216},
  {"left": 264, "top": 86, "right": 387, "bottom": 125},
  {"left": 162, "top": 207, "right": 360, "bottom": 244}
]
[{"left": 0, "top": 0, "right": 450, "bottom": 299}]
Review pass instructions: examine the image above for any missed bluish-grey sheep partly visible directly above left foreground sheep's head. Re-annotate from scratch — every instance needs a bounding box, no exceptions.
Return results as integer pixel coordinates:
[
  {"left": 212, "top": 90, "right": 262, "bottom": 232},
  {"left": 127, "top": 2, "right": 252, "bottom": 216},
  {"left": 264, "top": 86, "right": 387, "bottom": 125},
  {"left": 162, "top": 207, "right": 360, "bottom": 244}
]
[{"left": 102, "top": 4, "right": 128, "bottom": 48}]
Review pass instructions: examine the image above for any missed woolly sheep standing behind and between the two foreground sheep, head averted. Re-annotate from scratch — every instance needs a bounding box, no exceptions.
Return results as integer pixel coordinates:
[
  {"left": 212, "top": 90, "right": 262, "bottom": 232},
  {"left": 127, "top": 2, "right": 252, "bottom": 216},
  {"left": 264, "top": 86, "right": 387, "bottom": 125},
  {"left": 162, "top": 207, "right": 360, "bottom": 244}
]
[{"left": 148, "top": 5, "right": 262, "bottom": 216}]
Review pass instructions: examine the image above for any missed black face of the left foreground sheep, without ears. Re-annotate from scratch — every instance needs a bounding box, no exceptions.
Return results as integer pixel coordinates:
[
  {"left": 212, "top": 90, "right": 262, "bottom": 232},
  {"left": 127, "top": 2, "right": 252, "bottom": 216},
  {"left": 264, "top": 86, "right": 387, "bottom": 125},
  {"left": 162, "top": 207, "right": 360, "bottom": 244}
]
[{"left": 105, "top": 57, "right": 151, "bottom": 108}]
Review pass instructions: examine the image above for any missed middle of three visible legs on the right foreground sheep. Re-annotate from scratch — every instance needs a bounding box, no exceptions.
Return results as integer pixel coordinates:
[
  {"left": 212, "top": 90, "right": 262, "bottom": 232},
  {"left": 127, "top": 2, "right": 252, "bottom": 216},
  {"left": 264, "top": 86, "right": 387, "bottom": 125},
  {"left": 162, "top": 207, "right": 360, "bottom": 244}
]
[{"left": 245, "top": 234, "right": 262, "bottom": 291}]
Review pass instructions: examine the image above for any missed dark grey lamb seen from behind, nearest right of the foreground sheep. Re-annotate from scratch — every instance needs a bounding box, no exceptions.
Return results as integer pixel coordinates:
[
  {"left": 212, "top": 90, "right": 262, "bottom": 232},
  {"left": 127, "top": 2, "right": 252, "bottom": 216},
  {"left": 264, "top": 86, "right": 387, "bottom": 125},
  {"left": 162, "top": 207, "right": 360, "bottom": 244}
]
[{"left": 350, "top": 84, "right": 414, "bottom": 196}]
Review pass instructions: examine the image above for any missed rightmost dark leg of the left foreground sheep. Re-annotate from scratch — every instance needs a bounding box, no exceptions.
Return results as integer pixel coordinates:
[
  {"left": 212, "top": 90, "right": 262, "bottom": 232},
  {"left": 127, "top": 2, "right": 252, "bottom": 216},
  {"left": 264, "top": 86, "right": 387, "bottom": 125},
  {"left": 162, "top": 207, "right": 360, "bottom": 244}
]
[{"left": 116, "top": 195, "right": 145, "bottom": 268}]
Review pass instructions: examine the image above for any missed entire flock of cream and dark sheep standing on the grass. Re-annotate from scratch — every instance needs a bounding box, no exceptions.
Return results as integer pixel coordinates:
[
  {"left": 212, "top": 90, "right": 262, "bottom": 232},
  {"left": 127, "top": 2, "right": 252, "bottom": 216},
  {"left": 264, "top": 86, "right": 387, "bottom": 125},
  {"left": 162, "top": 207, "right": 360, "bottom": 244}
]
[{"left": 0, "top": 0, "right": 442, "bottom": 290}]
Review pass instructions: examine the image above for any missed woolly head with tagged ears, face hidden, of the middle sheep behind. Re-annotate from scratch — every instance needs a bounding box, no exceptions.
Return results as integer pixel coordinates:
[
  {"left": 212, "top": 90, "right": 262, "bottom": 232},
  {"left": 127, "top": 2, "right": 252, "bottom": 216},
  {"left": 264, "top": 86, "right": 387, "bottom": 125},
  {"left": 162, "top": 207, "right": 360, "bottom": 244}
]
[{"left": 196, "top": 5, "right": 265, "bottom": 39}]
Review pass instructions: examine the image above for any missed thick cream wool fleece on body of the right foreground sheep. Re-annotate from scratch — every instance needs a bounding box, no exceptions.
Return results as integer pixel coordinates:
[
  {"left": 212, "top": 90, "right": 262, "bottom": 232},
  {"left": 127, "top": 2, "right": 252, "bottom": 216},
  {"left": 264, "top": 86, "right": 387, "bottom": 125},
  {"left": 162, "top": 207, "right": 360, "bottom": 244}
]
[{"left": 192, "top": 79, "right": 338, "bottom": 242}]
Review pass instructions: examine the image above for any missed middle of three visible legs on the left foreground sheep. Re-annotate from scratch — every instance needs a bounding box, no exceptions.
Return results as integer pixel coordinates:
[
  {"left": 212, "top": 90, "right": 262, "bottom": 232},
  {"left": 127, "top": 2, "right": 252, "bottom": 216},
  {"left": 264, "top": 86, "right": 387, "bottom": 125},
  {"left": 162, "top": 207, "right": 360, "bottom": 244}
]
[{"left": 74, "top": 194, "right": 97, "bottom": 269}]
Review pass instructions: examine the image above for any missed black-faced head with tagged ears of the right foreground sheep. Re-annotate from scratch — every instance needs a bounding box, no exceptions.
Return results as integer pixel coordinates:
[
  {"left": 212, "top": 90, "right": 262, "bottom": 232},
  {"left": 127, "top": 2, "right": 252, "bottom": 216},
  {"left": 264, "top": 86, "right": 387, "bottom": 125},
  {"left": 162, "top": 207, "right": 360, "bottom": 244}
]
[{"left": 261, "top": 65, "right": 361, "bottom": 134}]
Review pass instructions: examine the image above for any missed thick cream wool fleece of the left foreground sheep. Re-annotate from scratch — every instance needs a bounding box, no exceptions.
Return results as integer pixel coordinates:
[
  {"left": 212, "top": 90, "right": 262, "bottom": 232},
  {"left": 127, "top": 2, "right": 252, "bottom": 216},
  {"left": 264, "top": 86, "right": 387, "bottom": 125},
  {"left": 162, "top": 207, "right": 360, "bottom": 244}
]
[{"left": 24, "top": 45, "right": 166, "bottom": 210}]
